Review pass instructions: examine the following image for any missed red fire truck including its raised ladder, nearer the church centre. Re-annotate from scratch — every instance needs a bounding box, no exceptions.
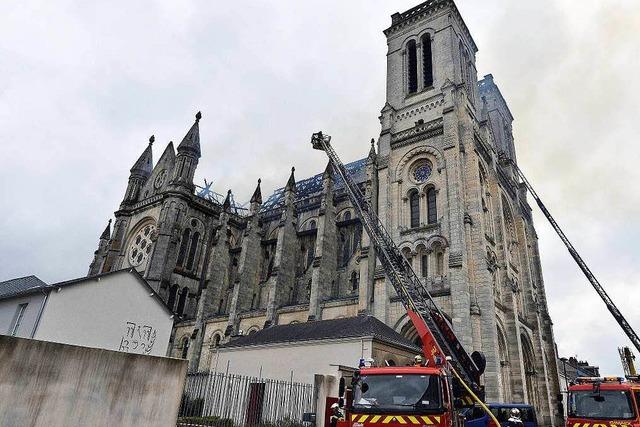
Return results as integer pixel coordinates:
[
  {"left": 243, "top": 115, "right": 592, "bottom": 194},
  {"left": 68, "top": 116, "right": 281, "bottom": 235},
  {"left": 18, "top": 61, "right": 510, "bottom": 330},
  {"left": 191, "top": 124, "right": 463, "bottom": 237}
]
[{"left": 311, "top": 132, "right": 500, "bottom": 427}]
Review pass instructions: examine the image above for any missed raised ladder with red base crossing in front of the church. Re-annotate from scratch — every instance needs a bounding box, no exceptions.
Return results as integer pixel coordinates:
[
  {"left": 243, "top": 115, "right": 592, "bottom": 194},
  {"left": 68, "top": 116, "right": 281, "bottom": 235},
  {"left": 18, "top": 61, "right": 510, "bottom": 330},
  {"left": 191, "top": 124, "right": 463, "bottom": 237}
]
[{"left": 311, "top": 132, "right": 485, "bottom": 398}]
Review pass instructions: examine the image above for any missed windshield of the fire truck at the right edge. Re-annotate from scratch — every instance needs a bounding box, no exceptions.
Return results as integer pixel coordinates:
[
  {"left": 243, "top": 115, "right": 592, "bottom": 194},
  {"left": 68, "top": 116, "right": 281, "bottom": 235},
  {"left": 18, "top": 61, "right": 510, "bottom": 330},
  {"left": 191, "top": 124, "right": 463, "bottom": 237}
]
[{"left": 569, "top": 390, "right": 634, "bottom": 420}]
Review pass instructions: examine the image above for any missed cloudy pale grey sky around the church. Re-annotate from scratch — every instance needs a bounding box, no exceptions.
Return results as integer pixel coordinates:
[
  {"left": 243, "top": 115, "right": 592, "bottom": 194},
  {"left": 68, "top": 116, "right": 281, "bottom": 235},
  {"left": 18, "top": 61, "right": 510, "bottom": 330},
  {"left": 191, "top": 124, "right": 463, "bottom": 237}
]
[{"left": 0, "top": 0, "right": 640, "bottom": 373}]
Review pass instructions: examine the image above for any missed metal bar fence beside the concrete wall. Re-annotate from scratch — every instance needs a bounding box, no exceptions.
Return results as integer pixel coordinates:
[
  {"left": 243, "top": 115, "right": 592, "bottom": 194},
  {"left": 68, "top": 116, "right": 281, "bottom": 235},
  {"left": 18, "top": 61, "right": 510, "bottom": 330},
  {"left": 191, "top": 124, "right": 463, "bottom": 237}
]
[{"left": 179, "top": 372, "right": 314, "bottom": 425}]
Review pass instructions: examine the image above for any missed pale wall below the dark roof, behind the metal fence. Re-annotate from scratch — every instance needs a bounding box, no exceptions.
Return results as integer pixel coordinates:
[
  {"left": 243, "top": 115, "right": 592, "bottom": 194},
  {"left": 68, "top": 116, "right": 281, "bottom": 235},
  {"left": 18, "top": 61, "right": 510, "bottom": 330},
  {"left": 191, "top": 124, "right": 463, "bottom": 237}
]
[{"left": 211, "top": 338, "right": 372, "bottom": 384}]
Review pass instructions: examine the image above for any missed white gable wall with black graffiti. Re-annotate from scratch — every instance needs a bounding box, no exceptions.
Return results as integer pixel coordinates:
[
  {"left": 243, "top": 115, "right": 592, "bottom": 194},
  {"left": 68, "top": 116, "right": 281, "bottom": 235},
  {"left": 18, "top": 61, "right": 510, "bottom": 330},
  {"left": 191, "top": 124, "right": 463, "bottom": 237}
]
[{"left": 34, "top": 271, "right": 173, "bottom": 356}]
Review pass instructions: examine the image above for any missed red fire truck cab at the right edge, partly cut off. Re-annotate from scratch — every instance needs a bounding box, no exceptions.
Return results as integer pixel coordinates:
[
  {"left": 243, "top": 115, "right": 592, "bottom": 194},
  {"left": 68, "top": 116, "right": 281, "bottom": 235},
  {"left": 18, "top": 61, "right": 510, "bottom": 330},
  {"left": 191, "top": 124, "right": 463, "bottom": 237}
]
[{"left": 567, "top": 377, "right": 640, "bottom": 427}]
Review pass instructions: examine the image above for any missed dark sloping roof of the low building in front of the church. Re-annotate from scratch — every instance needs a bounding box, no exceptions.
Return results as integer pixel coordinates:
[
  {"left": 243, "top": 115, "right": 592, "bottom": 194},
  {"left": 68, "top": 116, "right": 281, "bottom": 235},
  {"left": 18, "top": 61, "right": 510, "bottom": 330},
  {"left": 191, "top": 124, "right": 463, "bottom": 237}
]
[{"left": 220, "top": 316, "right": 422, "bottom": 353}]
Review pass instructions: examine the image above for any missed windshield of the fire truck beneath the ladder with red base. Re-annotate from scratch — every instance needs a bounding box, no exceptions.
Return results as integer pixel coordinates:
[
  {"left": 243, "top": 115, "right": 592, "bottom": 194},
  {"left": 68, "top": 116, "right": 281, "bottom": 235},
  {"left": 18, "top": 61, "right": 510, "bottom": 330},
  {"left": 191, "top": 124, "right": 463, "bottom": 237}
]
[{"left": 353, "top": 374, "right": 441, "bottom": 412}]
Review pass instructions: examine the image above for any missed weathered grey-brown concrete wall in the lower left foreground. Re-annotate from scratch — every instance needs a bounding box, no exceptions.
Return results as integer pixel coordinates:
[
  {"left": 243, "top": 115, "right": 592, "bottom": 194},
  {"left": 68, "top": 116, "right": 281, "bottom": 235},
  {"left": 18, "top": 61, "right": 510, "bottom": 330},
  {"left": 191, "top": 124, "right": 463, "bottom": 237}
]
[{"left": 0, "top": 336, "right": 187, "bottom": 427}]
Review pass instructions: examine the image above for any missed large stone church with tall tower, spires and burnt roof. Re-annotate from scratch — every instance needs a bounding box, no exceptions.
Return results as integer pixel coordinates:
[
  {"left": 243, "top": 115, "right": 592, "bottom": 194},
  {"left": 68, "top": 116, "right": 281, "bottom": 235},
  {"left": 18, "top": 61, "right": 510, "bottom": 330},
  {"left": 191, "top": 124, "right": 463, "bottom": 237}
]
[{"left": 89, "top": 0, "right": 560, "bottom": 425}]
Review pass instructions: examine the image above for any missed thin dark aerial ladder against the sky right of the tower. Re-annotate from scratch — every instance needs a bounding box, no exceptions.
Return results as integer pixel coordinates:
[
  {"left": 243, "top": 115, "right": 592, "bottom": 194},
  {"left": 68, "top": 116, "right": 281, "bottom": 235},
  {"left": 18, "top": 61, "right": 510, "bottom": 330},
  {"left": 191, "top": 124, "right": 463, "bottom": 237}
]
[{"left": 500, "top": 153, "right": 640, "bottom": 351}]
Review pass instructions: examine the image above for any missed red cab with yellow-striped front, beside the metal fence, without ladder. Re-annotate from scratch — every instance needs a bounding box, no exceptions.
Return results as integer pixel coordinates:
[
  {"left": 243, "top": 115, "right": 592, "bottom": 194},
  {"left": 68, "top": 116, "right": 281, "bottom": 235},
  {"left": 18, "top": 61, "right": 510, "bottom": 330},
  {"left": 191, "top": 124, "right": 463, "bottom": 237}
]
[{"left": 338, "top": 366, "right": 462, "bottom": 427}]
